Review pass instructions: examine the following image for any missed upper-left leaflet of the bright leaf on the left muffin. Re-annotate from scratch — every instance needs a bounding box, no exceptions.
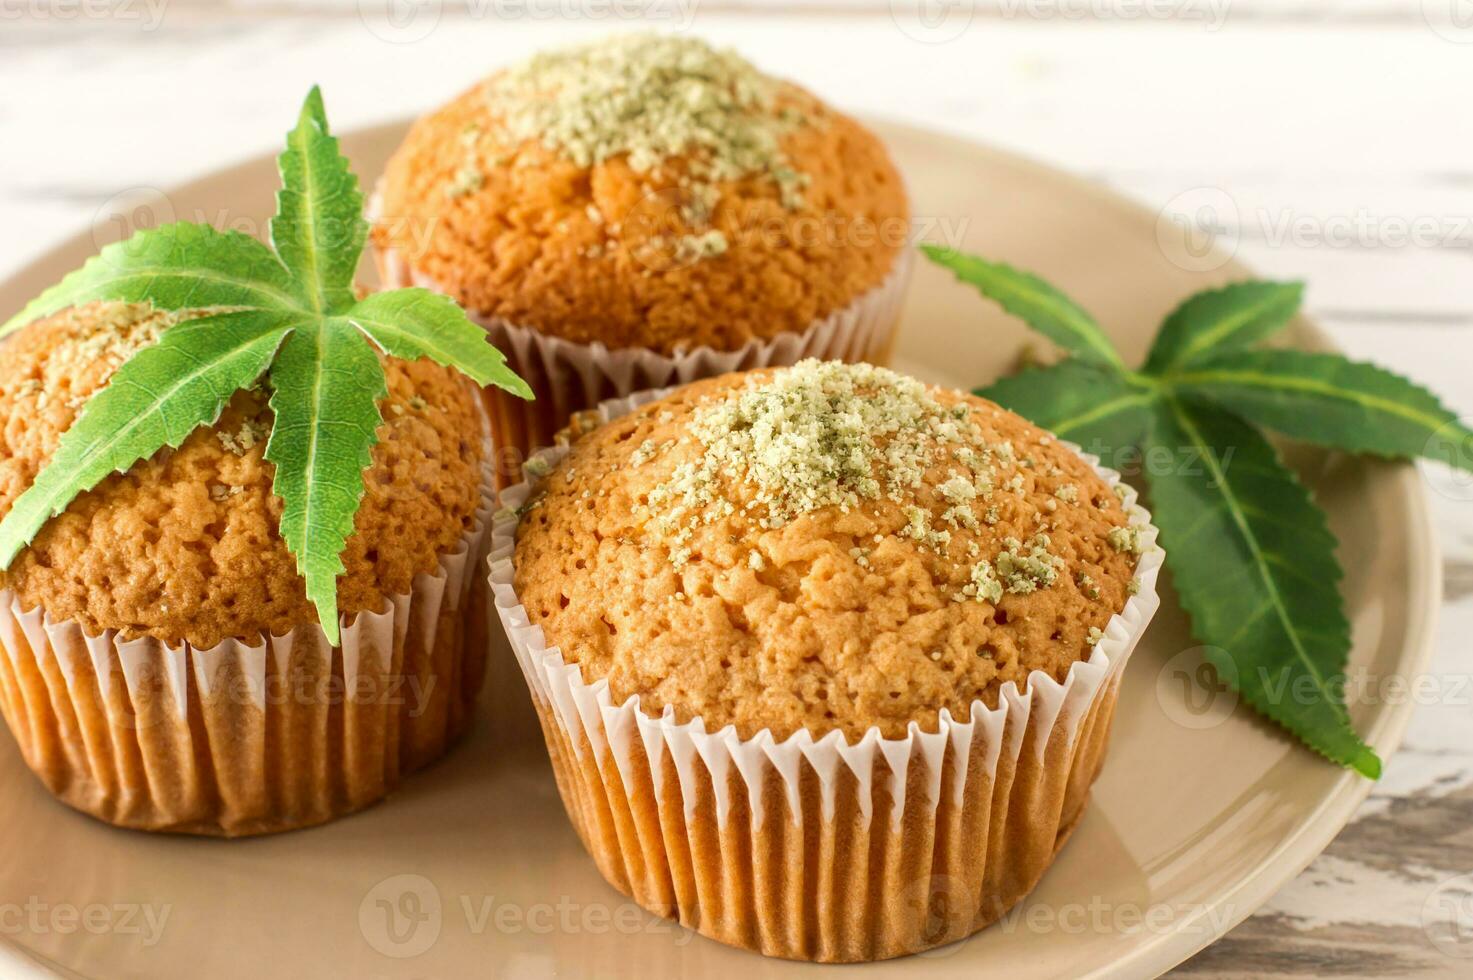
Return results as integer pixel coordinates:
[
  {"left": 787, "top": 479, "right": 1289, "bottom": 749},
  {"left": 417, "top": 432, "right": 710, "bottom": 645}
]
[{"left": 0, "top": 223, "right": 306, "bottom": 336}]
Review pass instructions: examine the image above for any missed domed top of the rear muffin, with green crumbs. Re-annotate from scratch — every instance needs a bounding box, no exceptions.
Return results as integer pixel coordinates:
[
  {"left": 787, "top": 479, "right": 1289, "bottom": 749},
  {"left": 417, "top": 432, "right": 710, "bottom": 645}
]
[{"left": 373, "top": 34, "right": 909, "bottom": 352}]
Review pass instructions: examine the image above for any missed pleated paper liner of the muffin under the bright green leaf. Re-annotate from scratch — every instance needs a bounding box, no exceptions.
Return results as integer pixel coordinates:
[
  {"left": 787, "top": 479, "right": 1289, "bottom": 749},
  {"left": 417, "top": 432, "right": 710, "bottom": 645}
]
[{"left": 0, "top": 464, "right": 493, "bottom": 837}]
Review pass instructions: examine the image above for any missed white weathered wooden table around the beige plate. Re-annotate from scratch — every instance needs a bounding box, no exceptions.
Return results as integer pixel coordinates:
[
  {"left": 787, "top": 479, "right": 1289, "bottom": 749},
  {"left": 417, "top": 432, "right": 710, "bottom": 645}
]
[{"left": 0, "top": 0, "right": 1473, "bottom": 977}]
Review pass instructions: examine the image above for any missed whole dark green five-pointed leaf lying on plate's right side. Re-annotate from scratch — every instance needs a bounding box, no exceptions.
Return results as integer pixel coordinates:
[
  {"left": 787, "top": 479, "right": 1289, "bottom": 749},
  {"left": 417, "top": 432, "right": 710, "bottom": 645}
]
[{"left": 924, "top": 246, "right": 1473, "bottom": 778}]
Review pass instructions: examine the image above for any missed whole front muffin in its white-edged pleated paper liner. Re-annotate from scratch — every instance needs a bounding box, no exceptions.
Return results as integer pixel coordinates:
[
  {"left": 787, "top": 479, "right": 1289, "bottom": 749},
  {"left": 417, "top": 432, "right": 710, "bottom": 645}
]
[{"left": 492, "top": 361, "right": 1161, "bottom": 962}]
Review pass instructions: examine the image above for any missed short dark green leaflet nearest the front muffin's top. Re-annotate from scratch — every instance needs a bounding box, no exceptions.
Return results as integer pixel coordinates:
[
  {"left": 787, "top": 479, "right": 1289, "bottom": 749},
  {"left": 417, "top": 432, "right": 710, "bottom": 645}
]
[{"left": 975, "top": 360, "right": 1156, "bottom": 458}]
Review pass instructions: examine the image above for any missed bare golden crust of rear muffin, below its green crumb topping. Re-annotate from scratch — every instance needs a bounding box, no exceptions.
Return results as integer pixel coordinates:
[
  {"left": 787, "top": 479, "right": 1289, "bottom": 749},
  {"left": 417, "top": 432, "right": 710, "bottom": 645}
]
[{"left": 373, "top": 70, "right": 909, "bottom": 354}]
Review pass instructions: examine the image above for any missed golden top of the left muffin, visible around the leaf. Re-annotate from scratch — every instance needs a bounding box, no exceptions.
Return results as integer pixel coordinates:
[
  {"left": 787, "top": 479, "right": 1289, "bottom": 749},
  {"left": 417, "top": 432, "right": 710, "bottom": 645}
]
[{"left": 0, "top": 304, "right": 482, "bottom": 647}]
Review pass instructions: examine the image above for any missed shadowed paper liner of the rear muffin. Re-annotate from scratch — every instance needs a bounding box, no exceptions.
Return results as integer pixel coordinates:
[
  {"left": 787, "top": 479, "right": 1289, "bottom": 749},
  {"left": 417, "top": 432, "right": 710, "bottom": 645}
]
[{"left": 370, "top": 199, "right": 915, "bottom": 486}]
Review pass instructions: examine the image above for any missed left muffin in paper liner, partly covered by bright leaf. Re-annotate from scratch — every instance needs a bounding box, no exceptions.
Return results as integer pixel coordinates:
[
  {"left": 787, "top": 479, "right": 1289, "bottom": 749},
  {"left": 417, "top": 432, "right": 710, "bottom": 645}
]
[{"left": 0, "top": 305, "right": 491, "bottom": 836}]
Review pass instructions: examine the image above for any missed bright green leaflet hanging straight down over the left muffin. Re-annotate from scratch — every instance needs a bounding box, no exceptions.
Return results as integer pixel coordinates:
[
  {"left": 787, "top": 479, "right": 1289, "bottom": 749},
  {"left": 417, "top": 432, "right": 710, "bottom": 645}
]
[{"left": 265, "top": 327, "right": 389, "bottom": 645}]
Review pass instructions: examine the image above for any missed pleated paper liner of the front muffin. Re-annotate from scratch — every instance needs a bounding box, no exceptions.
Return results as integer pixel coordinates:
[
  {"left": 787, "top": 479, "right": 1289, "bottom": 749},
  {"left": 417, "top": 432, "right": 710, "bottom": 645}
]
[{"left": 491, "top": 392, "right": 1164, "bottom": 962}]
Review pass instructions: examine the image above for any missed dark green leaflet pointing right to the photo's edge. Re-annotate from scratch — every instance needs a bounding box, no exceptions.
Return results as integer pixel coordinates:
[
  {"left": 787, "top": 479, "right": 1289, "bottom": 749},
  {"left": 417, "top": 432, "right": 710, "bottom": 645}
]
[{"left": 1171, "top": 351, "right": 1473, "bottom": 470}]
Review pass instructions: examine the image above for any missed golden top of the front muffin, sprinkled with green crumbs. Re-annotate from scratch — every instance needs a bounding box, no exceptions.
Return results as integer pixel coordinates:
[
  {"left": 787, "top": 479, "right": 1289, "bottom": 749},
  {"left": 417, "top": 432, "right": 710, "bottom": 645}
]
[{"left": 514, "top": 361, "right": 1142, "bottom": 740}]
